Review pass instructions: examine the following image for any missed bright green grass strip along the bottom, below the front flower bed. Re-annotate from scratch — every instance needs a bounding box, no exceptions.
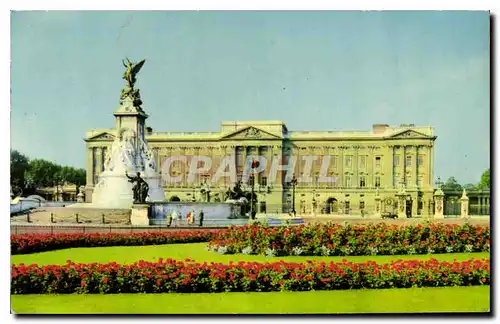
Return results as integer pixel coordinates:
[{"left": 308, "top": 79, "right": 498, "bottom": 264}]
[{"left": 11, "top": 286, "right": 490, "bottom": 314}]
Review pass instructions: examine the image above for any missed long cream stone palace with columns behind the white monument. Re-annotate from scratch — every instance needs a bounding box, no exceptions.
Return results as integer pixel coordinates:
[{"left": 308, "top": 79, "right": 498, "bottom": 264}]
[{"left": 85, "top": 107, "right": 436, "bottom": 216}]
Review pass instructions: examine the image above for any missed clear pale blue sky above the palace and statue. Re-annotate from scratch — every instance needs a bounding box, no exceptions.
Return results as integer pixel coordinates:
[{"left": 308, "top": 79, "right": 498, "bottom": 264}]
[{"left": 11, "top": 11, "right": 490, "bottom": 183}]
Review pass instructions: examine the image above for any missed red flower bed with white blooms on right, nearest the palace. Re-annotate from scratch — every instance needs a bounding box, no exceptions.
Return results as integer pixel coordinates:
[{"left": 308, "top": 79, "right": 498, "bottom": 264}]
[{"left": 208, "top": 223, "right": 490, "bottom": 256}]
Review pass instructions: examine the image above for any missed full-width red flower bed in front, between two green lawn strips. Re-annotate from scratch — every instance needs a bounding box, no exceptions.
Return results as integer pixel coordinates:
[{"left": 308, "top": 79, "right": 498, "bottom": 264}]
[{"left": 11, "top": 259, "right": 490, "bottom": 294}]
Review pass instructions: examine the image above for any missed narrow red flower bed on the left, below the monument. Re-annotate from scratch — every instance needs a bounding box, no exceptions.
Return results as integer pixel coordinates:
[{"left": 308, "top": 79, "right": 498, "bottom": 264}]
[{"left": 10, "top": 230, "right": 224, "bottom": 254}]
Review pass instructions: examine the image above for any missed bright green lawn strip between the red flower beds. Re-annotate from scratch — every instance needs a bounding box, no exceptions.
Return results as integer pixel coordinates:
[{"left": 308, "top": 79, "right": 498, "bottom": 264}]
[{"left": 11, "top": 243, "right": 490, "bottom": 265}]
